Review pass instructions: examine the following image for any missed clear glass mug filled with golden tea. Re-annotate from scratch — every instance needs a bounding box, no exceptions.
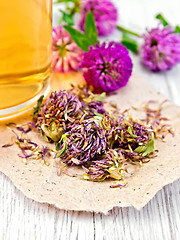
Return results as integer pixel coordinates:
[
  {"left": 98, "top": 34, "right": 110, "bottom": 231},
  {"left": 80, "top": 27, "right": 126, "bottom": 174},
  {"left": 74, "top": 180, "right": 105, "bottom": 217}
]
[{"left": 0, "top": 0, "right": 52, "bottom": 119}]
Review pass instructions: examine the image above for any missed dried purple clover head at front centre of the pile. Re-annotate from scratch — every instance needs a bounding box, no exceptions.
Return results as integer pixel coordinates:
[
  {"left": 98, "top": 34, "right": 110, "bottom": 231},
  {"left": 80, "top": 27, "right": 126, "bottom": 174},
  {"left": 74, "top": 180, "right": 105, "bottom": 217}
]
[{"left": 56, "top": 117, "right": 106, "bottom": 165}]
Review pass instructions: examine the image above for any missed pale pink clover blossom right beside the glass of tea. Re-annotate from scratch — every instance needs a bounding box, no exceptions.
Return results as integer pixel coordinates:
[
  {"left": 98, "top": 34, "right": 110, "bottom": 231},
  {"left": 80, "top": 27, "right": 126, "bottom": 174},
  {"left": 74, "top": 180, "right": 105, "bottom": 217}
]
[{"left": 52, "top": 26, "right": 82, "bottom": 73}]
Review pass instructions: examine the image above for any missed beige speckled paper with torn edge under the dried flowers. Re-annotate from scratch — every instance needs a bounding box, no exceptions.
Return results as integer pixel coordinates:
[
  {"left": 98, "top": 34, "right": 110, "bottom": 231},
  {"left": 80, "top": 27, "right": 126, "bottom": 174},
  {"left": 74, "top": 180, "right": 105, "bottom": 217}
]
[{"left": 0, "top": 74, "right": 180, "bottom": 213}]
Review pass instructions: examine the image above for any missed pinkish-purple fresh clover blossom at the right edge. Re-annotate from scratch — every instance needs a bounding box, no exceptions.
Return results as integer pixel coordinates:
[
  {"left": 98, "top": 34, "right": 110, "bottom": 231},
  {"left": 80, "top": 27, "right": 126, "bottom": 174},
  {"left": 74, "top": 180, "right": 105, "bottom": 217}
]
[{"left": 139, "top": 26, "right": 180, "bottom": 72}]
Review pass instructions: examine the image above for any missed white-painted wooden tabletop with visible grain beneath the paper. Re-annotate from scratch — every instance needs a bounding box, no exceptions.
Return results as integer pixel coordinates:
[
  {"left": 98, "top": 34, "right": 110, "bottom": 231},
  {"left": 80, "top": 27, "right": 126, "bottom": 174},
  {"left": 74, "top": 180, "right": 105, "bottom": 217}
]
[{"left": 0, "top": 0, "right": 180, "bottom": 240}]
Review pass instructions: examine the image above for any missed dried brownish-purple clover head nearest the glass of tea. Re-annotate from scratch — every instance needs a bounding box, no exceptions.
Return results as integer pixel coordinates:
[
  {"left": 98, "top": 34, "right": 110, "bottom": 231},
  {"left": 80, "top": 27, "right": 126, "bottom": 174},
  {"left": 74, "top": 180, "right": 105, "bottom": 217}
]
[{"left": 35, "top": 91, "right": 83, "bottom": 141}]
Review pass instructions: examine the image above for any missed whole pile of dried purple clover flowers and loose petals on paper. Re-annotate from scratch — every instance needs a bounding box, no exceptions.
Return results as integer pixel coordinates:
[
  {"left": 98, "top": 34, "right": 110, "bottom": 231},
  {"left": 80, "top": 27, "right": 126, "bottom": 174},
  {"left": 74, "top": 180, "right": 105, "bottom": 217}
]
[{"left": 4, "top": 86, "right": 173, "bottom": 187}]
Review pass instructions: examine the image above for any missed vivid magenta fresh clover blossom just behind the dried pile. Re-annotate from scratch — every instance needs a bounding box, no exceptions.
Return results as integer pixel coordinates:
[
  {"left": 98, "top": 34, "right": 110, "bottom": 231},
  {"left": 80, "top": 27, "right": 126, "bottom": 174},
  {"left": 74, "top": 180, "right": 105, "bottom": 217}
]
[{"left": 80, "top": 42, "right": 132, "bottom": 92}]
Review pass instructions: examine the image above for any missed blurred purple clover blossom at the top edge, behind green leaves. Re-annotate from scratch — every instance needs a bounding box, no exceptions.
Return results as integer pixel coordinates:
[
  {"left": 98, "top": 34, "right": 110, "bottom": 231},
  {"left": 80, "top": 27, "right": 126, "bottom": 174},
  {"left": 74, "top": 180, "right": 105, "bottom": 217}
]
[{"left": 79, "top": 0, "right": 118, "bottom": 36}]
